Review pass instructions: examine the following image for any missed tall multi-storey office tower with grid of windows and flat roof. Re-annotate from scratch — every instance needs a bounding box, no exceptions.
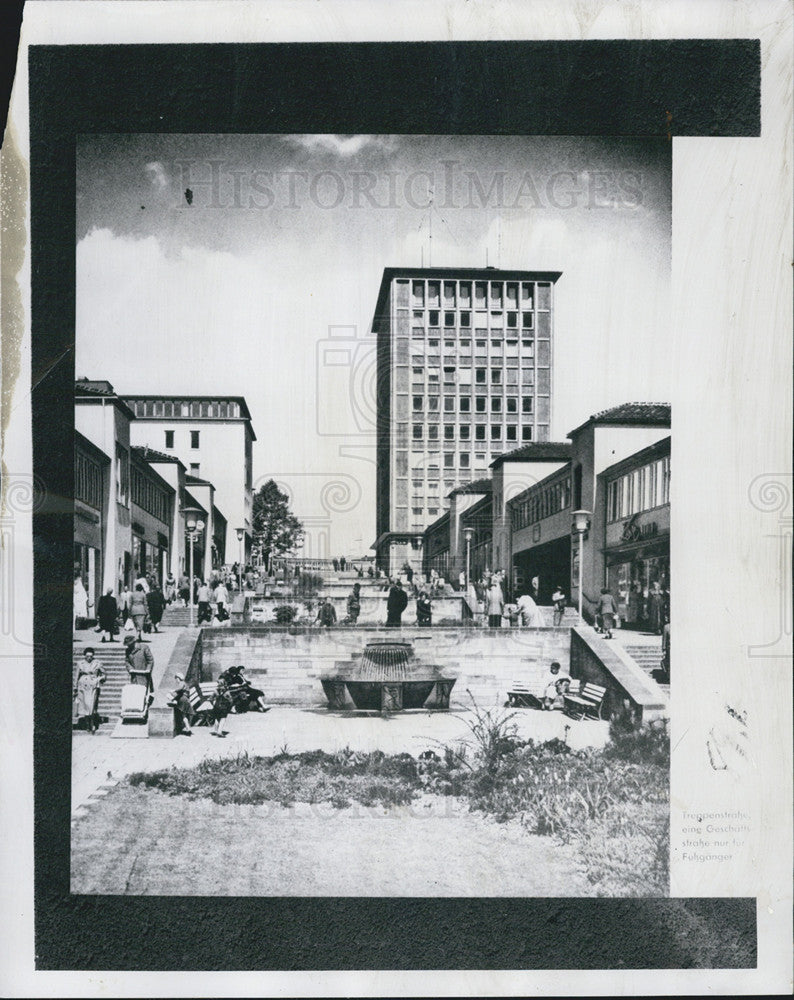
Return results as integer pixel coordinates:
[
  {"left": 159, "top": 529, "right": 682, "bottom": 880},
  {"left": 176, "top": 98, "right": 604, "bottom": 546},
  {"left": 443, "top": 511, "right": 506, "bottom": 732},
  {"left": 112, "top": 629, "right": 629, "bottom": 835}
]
[{"left": 372, "top": 267, "right": 560, "bottom": 572}]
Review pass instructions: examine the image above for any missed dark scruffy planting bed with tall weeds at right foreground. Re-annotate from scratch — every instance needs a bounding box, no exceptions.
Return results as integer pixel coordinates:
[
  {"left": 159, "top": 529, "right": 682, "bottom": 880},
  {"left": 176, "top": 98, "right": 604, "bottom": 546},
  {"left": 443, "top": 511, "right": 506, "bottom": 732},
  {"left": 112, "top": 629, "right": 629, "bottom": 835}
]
[{"left": 129, "top": 706, "right": 670, "bottom": 896}]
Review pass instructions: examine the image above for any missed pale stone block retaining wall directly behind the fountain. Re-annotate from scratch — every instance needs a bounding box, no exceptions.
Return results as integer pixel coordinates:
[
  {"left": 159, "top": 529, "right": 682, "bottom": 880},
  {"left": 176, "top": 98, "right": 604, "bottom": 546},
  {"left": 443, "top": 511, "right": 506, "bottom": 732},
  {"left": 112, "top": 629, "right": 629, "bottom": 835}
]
[{"left": 202, "top": 625, "right": 570, "bottom": 708}]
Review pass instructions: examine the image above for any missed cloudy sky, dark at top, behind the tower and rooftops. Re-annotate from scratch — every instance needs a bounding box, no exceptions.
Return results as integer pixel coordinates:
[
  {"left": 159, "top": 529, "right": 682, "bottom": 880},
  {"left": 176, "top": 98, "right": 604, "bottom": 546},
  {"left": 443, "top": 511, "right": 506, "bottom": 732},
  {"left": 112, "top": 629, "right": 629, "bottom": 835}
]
[{"left": 76, "top": 135, "right": 671, "bottom": 556}]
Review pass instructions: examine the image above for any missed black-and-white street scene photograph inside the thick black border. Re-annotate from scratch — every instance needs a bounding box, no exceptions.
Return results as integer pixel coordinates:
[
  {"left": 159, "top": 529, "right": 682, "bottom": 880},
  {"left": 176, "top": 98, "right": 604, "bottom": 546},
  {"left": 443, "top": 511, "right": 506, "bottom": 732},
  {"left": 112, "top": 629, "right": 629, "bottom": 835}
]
[{"left": 66, "top": 134, "right": 672, "bottom": 897}]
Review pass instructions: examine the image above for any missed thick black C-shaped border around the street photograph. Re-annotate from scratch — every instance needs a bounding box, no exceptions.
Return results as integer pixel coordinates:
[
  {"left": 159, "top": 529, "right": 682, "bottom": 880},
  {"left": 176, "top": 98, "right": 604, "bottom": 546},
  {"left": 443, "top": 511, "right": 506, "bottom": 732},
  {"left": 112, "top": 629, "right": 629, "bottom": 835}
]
[{"left": 29, "top": 39, "right": 761, "bottom": 971}]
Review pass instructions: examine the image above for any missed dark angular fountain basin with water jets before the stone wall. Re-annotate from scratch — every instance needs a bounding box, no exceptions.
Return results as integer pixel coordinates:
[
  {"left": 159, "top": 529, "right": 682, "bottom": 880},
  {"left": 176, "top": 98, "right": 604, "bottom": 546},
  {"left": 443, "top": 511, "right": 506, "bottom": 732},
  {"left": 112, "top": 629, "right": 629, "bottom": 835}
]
[{"left": 321, "top": 639, "right": 455, "bottom": 713}]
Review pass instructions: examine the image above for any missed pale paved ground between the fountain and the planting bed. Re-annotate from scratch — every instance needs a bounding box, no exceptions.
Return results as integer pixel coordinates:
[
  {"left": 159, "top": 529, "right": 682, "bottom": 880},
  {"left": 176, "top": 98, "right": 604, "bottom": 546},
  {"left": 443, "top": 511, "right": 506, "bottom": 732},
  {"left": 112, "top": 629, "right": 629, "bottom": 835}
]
[{"left": 72, "top": 700, "right": 609, "bottom": 818}]
